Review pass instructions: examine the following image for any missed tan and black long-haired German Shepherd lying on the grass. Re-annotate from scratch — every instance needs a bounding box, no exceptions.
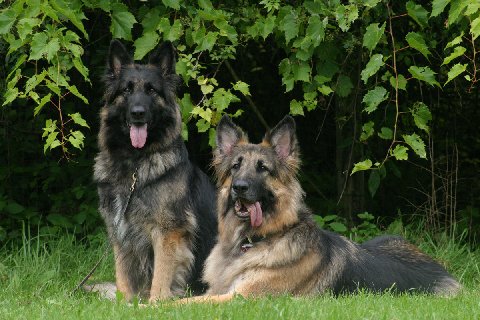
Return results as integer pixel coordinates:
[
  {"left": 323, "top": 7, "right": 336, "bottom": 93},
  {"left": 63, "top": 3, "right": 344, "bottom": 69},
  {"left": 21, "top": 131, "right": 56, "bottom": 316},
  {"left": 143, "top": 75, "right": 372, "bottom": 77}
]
[{"left": 181, "top": 116, "right": 460, "bottom": 302}]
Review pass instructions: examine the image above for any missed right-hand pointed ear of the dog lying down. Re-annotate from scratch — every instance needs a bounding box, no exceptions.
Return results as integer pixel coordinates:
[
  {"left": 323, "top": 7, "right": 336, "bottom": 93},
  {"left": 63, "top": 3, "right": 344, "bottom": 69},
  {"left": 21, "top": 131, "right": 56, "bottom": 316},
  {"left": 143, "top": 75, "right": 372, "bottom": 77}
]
[{"left": 263, "top": 115, "right": 297, "bottom": 160}]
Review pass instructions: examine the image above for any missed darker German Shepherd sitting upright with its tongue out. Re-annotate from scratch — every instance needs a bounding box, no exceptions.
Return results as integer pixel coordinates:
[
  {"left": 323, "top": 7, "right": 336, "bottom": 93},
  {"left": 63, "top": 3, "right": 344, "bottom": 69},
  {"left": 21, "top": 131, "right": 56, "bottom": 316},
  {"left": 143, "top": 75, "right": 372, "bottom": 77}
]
[{"left": 94, "top": 40, "right": 217, "bottom": 302}]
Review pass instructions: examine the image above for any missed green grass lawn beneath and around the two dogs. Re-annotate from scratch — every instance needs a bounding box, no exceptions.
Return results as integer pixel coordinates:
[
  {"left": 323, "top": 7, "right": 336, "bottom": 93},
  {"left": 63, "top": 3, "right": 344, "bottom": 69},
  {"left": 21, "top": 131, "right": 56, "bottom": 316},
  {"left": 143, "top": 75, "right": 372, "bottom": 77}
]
[{"left": 0, "top": 230, "right": 480, "bottom": 320}]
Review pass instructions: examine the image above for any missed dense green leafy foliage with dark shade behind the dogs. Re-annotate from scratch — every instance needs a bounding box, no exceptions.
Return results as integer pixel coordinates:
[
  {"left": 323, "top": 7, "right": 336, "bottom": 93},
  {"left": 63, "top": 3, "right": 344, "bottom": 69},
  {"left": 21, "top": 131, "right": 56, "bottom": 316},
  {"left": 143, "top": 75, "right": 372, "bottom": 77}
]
[{"left": 0, "top": 0, "right": 480, "bottom": 240}]
